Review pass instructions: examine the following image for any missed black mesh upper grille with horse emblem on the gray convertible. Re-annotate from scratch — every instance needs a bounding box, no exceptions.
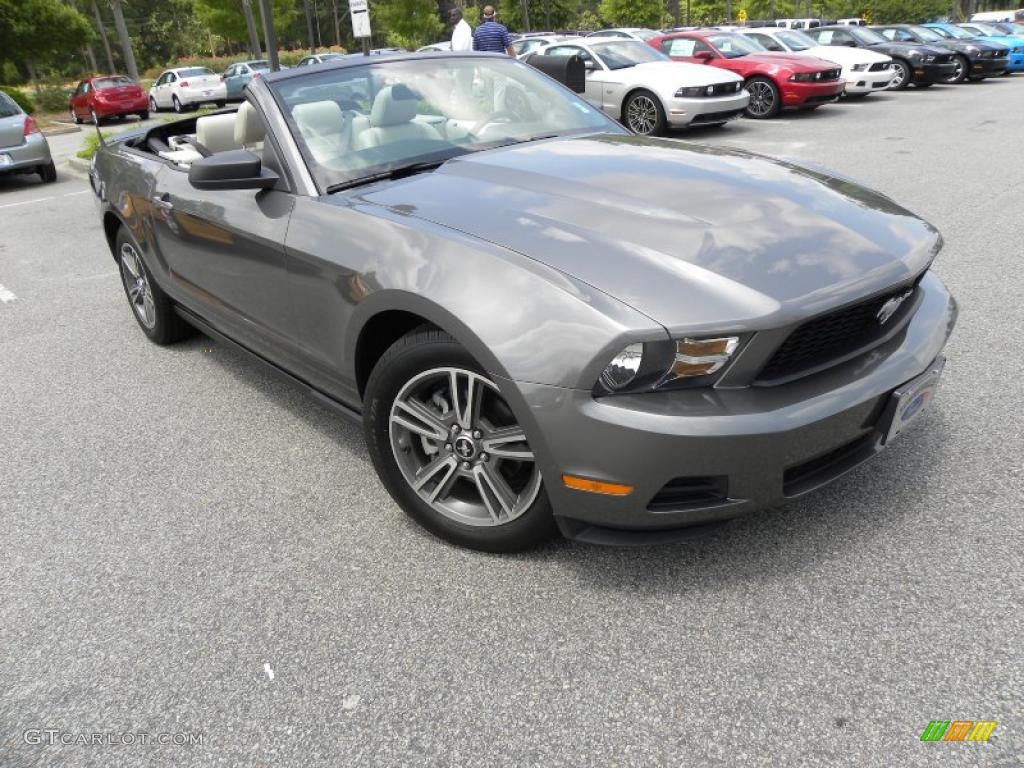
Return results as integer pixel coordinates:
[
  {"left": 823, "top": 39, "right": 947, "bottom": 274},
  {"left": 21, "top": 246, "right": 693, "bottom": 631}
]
[{"left": 758, "top": 285, "right": 914, "bottom": 384}]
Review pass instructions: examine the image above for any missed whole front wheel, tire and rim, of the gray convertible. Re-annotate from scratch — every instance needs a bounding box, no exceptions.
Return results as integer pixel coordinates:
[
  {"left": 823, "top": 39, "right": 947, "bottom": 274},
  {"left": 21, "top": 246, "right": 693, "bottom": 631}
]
[{"left": 364, "top": 329, "right": 555, "bottom": 552}]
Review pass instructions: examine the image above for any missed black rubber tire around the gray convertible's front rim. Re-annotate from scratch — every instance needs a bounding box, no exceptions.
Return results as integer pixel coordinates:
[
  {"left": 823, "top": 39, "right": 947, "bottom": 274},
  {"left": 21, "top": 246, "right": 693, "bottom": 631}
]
[{"left": 362, "top": 328, "right": 556, "bottom": 552}]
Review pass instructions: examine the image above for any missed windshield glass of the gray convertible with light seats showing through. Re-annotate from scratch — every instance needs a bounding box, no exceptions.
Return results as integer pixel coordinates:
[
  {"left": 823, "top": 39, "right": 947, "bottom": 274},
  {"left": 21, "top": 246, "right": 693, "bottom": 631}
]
[{"left": 268, "top": 56, "right": 624, "bottom": 191}]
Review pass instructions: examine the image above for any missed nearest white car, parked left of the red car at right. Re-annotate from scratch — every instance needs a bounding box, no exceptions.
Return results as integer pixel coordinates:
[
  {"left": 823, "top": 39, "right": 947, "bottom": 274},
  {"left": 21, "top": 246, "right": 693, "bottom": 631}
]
[{"left": 541, "top": 38, "right": 751, "bottom": 135}]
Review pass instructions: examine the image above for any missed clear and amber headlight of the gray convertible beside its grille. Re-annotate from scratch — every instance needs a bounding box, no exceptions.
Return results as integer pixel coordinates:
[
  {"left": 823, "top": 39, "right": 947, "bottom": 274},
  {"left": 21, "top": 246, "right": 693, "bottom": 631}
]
[{"left": 594, "top": 336, "right": 740, "bottom": 395}]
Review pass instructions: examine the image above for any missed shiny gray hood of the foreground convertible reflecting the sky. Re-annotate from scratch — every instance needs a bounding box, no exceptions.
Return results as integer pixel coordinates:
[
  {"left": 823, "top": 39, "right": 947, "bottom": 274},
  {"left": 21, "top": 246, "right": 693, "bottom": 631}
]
[{"left": 350, "top": 135, "right": 941, "bottom": 332}]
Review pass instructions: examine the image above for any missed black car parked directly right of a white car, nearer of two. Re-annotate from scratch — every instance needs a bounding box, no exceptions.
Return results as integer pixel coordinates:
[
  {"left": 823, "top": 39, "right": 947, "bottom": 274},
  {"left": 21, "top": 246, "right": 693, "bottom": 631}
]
[{"left": 805, "top": 25, "right": 956, "bottom": 88}]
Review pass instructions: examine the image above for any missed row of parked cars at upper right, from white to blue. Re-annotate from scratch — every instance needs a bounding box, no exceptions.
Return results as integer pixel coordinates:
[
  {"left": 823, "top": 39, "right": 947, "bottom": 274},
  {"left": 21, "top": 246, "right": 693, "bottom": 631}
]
[{"left": 415, "top": 22, "right": 1024, "bottom": 134}]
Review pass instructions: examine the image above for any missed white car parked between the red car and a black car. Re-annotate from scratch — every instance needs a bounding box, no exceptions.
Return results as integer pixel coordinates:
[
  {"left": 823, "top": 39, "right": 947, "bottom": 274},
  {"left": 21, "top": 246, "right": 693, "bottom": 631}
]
[{"left": 737, "top": 27, "right": 896, "bottom": 96}]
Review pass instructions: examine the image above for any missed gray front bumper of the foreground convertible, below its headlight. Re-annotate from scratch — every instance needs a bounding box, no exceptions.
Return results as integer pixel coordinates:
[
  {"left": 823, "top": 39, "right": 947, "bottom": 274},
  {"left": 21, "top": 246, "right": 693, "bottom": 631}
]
[{"left": 506, "top": 273, "right": 956, "bottom": 543}]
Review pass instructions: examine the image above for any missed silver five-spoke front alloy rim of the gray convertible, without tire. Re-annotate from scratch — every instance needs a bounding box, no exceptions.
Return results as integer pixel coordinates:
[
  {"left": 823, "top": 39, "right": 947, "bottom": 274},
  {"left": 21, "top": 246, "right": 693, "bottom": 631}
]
[{"left": 388, "top": 368, "right": 541, "bottom": 526}]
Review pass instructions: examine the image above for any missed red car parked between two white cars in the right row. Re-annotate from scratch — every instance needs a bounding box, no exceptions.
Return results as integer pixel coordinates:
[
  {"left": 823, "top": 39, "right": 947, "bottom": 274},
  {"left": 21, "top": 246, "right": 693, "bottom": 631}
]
[{"left": 647, "top": 30, "right": 846, "bottom": 119}]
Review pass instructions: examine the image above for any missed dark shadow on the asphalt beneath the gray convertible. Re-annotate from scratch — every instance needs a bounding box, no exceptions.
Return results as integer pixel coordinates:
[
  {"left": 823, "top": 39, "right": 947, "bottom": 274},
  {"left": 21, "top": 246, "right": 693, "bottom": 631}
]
[{"left": 179, "top": 327, "right": 952, "bottom": 594}]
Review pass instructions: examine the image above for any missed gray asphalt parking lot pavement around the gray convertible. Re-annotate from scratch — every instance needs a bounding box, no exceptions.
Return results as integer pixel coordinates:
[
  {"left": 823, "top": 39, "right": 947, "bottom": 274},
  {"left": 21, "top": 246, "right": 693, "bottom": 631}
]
[{"left": 0, "top": 76, "right": 1024, "bottom": 768}]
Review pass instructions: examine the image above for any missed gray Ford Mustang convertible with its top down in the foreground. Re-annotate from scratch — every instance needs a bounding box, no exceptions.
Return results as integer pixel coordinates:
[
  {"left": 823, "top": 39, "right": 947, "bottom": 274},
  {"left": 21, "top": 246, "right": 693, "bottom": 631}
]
[{"left": 92, "top": 54, "right": 956, "bottom": 551}]
